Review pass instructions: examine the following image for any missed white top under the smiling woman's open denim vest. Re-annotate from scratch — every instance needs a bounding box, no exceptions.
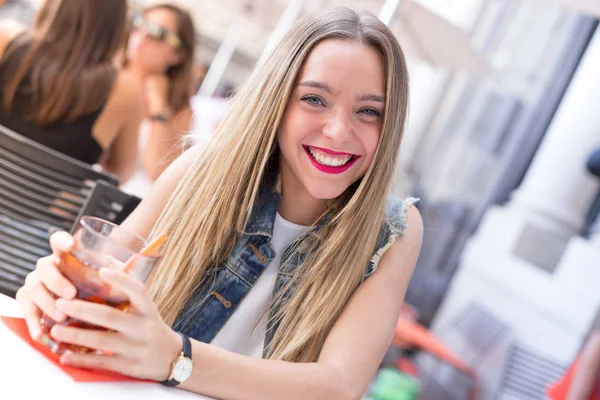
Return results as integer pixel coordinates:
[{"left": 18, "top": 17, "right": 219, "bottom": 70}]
[{"left": 211, "top": 213, "right": 310, "bottom": 358}]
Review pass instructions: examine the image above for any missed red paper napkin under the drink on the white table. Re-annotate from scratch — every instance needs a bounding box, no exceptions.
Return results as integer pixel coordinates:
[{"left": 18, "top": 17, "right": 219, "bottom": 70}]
[{"left": 2, "top": 317, "right": 154, "bottom": 382}]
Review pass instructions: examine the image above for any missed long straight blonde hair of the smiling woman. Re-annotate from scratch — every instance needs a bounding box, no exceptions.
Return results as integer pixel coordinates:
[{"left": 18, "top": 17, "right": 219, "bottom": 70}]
[{"left": 150, "top": 8, "right": 408, "bottom": 362}]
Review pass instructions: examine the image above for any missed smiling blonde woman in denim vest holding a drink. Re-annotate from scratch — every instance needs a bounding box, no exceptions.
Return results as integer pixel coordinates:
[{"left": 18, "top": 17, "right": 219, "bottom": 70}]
[{"left": 17, "top": 8, "right": 422, "bottom": 399}]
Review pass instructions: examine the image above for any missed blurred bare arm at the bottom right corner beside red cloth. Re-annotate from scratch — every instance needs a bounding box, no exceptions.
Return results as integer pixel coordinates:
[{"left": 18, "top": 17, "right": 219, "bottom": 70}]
[{"left": 567, "top": 333, "right": 600, "bottom": 400}]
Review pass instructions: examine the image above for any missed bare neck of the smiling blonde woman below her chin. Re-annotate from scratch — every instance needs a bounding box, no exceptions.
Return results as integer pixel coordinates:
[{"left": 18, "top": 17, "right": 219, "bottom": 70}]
[{"left": 277, "top": 163, "right": 327, "bottom": 226}]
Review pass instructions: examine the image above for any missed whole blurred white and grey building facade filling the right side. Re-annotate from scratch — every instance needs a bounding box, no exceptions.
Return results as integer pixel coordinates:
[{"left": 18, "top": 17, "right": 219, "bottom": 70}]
[{"left": 400, "top": 1, "right": 600, "bottom": 399}]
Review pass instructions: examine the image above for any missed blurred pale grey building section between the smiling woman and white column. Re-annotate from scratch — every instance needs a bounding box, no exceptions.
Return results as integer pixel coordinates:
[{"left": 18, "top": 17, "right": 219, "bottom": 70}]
[{"left": 398, "top": 0, "right": 596, "bottom": 323}]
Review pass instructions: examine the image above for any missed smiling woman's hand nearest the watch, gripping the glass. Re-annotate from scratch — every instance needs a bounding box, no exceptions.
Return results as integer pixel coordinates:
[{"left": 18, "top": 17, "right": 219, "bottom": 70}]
[{"left": 50, "top": 268, "right": 181, "bottom": 381}]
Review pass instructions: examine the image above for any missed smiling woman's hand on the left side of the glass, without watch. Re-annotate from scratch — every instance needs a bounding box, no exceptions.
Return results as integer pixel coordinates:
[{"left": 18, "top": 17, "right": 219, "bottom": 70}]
[{"left": 17, "top": 232, "right": 77, "bottom": 340}]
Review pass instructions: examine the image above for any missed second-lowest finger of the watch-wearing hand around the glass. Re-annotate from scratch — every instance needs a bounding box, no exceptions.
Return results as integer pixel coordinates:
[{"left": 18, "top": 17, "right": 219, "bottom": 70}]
[{"left": 50, "top": 325, "right": 134, "bottom": 354}]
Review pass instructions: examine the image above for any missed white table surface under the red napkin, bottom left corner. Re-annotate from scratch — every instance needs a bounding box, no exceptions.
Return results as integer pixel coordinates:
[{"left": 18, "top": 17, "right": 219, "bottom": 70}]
[{"left": 0, "top": 294, "right": 210, "bottom": 400}]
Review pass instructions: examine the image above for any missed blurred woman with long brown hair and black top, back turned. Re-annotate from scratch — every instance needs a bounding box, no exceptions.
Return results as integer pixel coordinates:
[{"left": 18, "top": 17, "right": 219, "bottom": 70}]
[{"left": 0, "top": 0, "right": 143, "bottom": 181}]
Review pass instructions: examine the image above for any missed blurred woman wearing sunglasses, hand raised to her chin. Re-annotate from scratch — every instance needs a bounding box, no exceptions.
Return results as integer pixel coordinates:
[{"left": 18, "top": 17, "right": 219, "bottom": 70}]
[{"left": 126, "top": 4, "right": 195, "bottom": 189}]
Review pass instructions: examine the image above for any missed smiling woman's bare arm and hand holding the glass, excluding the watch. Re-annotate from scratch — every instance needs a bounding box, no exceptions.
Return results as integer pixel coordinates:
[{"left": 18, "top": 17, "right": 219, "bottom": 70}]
[{"left": 51, "top": 206, "right": 422, "bottom": 400}]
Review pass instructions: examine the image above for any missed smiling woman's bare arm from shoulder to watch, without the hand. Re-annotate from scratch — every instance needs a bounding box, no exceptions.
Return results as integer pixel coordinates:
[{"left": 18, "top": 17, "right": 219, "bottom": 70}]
[{"left": 181, "top": 207, "right": 422, "bottom": 400}]
